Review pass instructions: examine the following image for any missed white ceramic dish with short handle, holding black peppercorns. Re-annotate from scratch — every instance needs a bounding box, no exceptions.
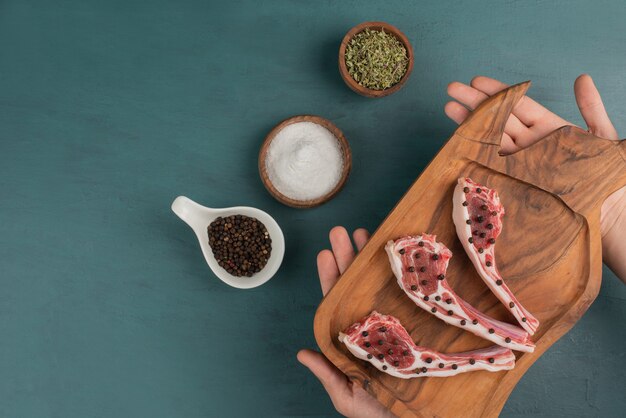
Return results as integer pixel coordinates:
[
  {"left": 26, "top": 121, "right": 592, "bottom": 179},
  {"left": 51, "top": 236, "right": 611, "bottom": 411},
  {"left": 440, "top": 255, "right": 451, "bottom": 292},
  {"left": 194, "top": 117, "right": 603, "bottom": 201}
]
[{"left": 172, "top": 196, "right": 285, "bottom": 289}]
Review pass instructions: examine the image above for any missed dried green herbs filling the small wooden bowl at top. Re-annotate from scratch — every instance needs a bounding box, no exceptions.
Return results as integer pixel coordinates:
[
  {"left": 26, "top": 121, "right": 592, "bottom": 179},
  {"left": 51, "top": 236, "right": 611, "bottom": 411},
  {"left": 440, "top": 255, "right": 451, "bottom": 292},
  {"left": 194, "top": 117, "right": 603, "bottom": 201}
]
[{"left": 345, "top": 28, "right": 409, "bottom": 90}]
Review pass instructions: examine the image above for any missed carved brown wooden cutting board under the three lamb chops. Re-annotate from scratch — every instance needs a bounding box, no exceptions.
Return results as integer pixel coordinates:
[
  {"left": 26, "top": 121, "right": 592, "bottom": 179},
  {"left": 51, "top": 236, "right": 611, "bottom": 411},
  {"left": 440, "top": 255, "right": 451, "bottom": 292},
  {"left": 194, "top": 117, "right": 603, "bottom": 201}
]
[{"left": 314, "top": 82, "right": 626, "bottom": 417}]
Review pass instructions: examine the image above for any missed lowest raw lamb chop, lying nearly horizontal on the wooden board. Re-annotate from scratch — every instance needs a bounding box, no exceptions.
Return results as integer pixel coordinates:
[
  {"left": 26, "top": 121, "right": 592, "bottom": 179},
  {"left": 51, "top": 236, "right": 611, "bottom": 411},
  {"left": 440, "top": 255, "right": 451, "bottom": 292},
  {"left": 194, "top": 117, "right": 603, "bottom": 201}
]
[{"left": 339, "top": 311, "right": 515, "bottom": 379}]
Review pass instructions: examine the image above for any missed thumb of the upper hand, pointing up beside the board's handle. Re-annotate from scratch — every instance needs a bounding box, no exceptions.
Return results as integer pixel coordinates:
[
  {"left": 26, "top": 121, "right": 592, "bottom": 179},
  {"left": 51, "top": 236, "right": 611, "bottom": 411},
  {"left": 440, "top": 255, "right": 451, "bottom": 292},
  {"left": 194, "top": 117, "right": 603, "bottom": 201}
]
[{"left": 574, "top": 74, "right": 618, "bottom": 139}]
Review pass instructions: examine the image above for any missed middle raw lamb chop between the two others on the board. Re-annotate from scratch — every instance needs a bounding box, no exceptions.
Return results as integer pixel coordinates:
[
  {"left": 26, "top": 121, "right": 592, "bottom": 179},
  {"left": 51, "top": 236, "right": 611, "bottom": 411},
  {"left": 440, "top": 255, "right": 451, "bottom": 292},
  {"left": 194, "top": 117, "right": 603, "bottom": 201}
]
[{"left": 385, "top": 234, "right": 535, "bottom": 353}]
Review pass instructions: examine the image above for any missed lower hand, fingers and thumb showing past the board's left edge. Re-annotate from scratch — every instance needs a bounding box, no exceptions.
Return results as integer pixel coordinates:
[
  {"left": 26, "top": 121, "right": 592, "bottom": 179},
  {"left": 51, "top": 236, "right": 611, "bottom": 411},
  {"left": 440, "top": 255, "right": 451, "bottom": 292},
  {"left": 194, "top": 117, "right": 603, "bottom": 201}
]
[{"left": 298, "top": 226, "right": 395, "bottom": 418}]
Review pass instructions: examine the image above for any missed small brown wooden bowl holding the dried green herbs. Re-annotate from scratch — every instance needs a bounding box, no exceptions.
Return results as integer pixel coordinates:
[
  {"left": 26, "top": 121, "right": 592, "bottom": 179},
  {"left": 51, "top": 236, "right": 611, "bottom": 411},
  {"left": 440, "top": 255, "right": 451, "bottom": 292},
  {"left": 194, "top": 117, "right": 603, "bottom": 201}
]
[{"left": 339, "top": 22, "right": 413, "bottom": 98}]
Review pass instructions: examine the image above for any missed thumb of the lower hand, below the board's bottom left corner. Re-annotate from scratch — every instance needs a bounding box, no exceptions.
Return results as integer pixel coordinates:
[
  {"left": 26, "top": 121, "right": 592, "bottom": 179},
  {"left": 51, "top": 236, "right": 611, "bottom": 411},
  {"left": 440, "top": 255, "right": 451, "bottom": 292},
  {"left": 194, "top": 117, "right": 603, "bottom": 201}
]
[{"left": 298, "top": 350, "right": 350, "bottom": 407}]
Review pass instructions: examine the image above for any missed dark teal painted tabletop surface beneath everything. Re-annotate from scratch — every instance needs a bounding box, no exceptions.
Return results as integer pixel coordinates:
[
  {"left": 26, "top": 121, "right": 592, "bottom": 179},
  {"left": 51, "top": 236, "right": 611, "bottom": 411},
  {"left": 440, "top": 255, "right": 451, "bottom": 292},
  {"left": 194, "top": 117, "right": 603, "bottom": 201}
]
[{"left": 0, "top": 0, "right": 626, "bottom": 418}]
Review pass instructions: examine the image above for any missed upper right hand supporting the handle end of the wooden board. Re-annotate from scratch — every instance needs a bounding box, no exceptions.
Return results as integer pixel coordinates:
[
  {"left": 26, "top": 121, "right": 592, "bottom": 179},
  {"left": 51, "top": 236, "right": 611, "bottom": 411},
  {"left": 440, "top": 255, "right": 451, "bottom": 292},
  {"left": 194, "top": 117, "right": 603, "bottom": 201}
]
[{"left": 445, "top": 74, "right": 626, "bottom": 282}]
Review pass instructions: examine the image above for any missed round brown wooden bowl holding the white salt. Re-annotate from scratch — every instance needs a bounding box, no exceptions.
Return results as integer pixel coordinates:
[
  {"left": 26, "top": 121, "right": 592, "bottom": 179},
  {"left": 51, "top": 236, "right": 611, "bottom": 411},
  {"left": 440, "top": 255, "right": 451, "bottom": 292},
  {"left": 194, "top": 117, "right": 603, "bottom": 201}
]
[{"left": 259, "top": 115, "right": 352, "bottom": 208}]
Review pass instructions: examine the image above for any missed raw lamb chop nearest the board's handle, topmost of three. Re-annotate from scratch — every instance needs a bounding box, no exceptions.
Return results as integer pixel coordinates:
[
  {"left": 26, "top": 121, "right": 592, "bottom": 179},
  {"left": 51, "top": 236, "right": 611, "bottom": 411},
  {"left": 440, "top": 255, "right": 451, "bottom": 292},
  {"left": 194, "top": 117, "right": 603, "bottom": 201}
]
[{"left": 452, "top": 178, "right": 539, "bottom": 335}]
